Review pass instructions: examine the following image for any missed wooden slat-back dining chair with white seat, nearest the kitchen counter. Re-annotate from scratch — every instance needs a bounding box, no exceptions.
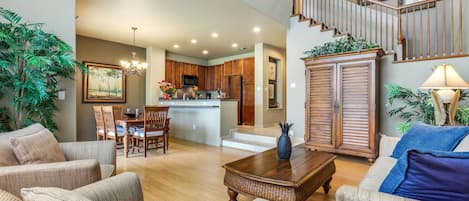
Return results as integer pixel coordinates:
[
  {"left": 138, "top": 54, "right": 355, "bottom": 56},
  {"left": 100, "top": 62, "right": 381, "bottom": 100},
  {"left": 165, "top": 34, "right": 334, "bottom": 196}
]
[{"left": 133, "top": 106, "right": 169, "bottom": 157}]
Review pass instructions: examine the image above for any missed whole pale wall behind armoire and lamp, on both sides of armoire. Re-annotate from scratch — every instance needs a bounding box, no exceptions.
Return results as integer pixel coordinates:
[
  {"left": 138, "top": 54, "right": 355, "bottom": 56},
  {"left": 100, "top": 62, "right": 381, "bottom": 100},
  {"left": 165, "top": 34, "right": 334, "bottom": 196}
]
[{"left": 287, "top": 14, "right": 469, "bottom": 137}]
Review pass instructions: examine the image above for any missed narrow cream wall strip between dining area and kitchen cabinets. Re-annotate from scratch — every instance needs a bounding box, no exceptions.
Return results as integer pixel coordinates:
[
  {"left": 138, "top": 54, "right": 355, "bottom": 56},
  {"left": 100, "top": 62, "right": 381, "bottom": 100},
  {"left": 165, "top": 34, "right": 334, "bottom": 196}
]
[{"left": 145, "top": 47, "right": 166, "bottom": 105}]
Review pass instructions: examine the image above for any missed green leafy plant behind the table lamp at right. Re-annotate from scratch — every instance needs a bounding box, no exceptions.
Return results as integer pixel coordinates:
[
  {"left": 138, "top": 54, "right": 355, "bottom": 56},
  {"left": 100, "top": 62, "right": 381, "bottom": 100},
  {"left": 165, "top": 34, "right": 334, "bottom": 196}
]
[{"left": 384, "top": 84, "right": 469, "bottom": 133}]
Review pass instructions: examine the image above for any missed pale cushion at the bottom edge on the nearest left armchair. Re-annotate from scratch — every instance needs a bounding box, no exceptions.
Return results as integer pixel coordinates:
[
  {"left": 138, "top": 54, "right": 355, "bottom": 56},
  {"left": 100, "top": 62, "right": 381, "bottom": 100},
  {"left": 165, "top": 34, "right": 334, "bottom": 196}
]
[{"left": 21, "top": 187, "right": 91, "bottom": 201}]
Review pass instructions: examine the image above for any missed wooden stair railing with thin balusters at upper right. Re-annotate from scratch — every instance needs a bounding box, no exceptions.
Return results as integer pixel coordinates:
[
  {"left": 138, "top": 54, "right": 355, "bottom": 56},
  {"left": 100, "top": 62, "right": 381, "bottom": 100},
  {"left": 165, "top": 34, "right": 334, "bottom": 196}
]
[{"left": 292, "top": 0, "right": 469, "bottom": 61}]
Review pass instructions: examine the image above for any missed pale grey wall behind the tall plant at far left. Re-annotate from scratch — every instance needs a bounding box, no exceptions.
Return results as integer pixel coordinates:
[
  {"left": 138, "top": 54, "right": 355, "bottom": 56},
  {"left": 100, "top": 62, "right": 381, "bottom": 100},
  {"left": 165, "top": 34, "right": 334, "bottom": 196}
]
[{"left": 0, "top": 0, "right": 76, "bottom": 141}]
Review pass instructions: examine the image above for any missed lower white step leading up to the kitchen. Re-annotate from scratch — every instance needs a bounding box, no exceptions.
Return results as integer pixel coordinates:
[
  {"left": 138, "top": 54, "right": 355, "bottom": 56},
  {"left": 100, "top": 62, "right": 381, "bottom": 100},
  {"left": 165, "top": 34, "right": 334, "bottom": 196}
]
[{"left": 222, "top": 138, "right": 276, "bottom": 152}]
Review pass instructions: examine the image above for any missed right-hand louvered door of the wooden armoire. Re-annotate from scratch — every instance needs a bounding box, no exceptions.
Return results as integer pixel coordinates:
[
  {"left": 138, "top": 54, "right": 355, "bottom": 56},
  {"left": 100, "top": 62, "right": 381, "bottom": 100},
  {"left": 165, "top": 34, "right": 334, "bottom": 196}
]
[{"left": 336, "top": 61, "right": 374, "bottom": 155}]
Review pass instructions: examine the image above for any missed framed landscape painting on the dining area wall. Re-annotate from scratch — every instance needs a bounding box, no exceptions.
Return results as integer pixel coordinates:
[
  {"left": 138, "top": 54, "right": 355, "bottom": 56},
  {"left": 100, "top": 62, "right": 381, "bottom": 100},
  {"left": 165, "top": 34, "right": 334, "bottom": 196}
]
[{"left": 83, "top": 62, "right": 126, "bottom": 103}]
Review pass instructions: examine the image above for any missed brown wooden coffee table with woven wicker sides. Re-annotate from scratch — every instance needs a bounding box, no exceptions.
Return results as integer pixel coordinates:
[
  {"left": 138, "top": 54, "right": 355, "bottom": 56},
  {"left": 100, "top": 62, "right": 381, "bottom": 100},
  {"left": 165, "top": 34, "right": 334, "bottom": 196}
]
[{"left": 223, "top": 144, "right": 336, "bottom": 201}]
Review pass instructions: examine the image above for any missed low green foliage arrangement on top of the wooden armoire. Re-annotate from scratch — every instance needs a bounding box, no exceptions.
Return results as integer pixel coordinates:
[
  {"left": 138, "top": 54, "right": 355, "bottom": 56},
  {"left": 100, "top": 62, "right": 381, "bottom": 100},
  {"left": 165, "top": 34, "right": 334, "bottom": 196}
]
[{"left": 305, "top": 37, "right": 379, "bottom": 57}]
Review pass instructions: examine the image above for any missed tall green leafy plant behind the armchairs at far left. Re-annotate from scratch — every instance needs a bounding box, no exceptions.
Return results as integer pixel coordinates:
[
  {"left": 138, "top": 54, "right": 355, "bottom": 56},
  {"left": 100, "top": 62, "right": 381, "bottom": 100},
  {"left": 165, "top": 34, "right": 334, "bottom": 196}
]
[{"left": 0, "top": 8, "right": 85, "bottom": 131}]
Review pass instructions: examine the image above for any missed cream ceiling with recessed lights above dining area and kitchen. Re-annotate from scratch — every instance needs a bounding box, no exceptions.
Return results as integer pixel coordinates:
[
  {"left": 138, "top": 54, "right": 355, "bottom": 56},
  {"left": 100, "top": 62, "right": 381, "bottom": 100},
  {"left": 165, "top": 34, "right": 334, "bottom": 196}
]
[{"left": 77, "top": 0, "right": 289, "bottom": 59}]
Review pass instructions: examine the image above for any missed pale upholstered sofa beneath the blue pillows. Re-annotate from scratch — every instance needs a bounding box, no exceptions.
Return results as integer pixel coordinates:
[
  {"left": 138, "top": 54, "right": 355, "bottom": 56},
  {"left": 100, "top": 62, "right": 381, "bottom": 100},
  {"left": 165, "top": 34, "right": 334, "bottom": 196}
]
[{"left": 336, "top": 135, "right": 469, "bottom": 201}]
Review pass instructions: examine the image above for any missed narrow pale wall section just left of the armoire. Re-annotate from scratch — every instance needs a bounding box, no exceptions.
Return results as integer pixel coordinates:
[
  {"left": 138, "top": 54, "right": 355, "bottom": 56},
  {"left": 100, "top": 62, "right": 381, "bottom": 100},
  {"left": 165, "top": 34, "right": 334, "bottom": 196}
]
[{"left": 286, "top": 17, "right": 334, "bottom": 137}]
